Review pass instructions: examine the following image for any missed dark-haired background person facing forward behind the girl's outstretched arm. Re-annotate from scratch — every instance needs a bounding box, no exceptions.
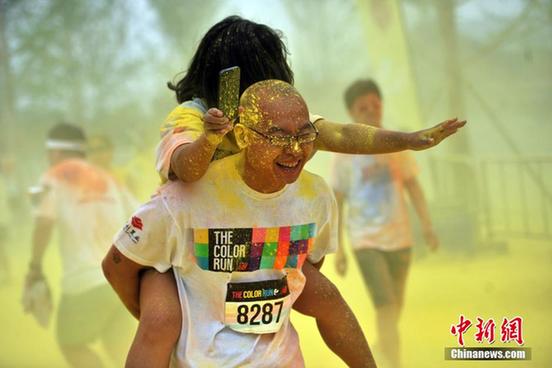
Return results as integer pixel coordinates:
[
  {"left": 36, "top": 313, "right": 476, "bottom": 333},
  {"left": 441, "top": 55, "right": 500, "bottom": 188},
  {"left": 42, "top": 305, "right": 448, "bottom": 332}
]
[{"left": 333, "top": 80, "right": 439, "bottom": 367}]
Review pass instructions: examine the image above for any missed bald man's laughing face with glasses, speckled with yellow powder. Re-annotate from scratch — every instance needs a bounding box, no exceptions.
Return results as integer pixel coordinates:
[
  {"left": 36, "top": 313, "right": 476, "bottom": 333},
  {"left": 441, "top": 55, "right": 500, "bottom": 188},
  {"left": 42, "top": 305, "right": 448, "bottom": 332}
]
[{"left": 246, "top": 95, "right": 315, "bottom": 190}]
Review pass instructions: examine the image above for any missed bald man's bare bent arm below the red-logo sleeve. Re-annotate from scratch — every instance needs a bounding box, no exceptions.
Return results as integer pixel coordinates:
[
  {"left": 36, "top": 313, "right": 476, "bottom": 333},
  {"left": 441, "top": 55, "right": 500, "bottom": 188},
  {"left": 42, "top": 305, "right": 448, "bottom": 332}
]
[{"left": 102, "top": 245, "right": 149, "bottom": 319}]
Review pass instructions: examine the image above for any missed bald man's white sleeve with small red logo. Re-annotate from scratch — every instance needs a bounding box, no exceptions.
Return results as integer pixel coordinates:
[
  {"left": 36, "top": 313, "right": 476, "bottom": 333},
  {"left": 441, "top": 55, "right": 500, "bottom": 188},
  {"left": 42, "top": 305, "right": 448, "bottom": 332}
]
[{"left": 113, "top": 195, "right": 177, "bottom": 272}]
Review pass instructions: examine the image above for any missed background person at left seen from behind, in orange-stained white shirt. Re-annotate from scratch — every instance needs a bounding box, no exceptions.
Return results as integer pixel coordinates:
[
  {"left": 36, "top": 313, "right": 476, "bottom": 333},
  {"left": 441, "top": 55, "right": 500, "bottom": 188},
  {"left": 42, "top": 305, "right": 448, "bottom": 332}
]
[{"left": 23, "top": 123, "right": 136, "bottom": 367}]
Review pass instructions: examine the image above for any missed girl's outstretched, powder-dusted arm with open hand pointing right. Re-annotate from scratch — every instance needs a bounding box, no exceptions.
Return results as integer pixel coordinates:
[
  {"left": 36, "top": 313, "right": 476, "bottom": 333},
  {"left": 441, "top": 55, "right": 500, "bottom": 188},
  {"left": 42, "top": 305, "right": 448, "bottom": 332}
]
[{"left": 315, "top": 118, "right": 466, "bottom": 154}]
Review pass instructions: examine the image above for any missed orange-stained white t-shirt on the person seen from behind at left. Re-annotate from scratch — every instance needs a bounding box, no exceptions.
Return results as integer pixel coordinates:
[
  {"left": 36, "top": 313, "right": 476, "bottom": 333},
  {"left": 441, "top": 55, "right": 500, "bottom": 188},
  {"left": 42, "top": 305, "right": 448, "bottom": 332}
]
[{"left": 34, "top": 159, "right": 133, "bottom": 294}]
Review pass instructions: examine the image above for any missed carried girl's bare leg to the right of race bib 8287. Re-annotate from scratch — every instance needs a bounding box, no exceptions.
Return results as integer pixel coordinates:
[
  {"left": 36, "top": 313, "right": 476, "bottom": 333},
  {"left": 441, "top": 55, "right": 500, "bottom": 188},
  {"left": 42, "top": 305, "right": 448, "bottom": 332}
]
[{"left": 293, "top": 262, "right": 376, "bottom": 367}]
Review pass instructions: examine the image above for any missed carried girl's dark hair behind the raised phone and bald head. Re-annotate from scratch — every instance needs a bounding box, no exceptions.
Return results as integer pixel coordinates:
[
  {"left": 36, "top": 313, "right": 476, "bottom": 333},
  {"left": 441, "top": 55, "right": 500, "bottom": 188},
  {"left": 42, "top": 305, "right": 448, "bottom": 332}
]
[{"left": 167, "top": 15, "right": 293, "bottom": 107}]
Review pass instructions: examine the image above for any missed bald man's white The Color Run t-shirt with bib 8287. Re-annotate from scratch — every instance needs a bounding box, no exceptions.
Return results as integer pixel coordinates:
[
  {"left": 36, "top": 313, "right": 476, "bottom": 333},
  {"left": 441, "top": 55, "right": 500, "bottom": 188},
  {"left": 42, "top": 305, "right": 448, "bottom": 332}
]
[{"left": 114, "top": 154, "right": 337, "bottom": 367}]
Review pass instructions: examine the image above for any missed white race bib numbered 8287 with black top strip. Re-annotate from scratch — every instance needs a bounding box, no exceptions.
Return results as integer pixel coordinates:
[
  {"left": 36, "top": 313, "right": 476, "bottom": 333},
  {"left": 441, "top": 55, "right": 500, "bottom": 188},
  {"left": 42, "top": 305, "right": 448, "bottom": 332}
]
[{"left": 224, "top": 277, "right": 291, "bottom": 334}]
